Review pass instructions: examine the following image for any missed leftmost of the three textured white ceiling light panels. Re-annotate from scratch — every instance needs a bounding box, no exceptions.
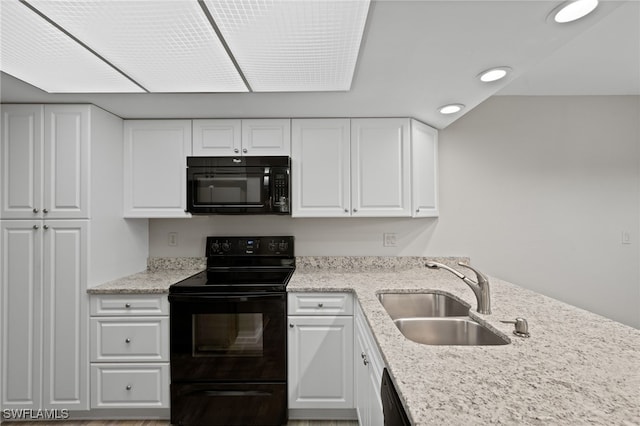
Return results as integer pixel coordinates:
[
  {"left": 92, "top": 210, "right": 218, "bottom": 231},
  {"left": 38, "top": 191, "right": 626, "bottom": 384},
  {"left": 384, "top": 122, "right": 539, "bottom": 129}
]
[{"left": 0, "top": 0, "right": 143, "bottom": 93}]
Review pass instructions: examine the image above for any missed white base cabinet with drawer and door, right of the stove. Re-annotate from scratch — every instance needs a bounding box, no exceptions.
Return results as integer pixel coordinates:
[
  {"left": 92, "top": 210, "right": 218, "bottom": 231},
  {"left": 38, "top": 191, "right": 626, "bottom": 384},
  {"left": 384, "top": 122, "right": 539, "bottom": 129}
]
[{"left": 288, "top": 293, "right": 354, "bottom": 418}]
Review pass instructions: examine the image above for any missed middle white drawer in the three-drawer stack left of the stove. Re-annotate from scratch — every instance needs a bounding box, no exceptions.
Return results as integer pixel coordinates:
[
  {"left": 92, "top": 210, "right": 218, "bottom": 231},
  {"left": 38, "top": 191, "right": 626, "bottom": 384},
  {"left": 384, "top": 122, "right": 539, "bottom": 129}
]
[{"left": 91, "top": 317, "right": 169, "bottom": 362}]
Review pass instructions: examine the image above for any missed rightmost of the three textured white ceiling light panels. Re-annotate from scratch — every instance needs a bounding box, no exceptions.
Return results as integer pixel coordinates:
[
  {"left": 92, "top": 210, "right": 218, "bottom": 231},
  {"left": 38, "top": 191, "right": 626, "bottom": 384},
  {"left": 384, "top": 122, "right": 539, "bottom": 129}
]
[{"left": 205, "top": 0, "right": 369, "bottom": 92}]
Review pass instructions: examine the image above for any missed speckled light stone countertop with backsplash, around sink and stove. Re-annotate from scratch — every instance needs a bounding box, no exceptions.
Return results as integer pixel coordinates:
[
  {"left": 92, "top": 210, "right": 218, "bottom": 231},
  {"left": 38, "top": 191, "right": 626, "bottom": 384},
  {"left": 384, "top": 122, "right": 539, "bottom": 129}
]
[{"left": 88, "top": 257, "right": 640, "bottom": 426}]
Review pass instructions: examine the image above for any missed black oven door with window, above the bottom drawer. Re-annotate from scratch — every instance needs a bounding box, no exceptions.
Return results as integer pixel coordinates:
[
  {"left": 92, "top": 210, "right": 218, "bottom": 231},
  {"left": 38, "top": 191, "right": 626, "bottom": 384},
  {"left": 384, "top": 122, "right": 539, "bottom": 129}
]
[{"left": 169, "top": 292, "right": 287, "bottom": 383}]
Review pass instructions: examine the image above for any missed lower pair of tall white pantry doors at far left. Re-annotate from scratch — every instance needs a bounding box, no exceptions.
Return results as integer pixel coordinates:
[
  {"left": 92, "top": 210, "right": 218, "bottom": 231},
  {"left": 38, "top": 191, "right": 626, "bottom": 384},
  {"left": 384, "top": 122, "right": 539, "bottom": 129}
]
[{"left": 0, "top": 220, "right": 89, "bottom": 410}]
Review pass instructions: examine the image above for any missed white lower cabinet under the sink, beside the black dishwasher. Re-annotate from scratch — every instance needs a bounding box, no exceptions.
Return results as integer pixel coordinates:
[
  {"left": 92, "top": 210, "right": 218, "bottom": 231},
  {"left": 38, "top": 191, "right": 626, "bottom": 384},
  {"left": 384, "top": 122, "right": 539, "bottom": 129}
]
[{"left": 353, "top": 303, "right": 384, "bottom": 426}]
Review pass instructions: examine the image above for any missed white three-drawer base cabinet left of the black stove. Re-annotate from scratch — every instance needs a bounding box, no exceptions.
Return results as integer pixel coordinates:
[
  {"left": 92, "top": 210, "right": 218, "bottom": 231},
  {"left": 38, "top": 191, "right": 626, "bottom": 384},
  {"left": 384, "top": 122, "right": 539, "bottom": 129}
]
[{"left": 90, "top": 295, "right": 169, "bottom": 409}]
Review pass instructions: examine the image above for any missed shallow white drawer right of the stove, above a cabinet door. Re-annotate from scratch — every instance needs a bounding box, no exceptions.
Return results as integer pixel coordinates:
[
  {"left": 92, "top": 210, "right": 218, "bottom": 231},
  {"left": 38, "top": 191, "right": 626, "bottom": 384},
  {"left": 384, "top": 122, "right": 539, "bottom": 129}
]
[{"left": 287, "top": 293, "right": 353, "bottom": 315}]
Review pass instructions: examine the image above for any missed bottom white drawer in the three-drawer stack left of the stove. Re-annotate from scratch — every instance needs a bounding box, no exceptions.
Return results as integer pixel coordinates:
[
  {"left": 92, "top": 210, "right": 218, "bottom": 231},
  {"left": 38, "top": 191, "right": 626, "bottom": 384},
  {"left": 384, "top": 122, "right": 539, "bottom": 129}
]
[{"left": 91, "top": 363, "right": 169, "bottom": 408}]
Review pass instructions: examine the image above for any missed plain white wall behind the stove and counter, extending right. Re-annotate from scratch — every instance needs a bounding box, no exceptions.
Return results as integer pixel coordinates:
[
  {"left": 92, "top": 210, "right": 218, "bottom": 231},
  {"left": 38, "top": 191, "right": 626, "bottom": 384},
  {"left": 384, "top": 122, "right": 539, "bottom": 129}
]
[{"left": 149, "top": 96, "right": 640, "bottom": 327}]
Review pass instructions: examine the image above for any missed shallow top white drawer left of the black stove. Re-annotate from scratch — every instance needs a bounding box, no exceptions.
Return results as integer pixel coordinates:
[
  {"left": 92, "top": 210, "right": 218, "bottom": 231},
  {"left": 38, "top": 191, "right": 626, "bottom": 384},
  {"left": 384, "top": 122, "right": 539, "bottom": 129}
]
[{"left": 91, "top": 294, "right": 169, "bottom": 316}]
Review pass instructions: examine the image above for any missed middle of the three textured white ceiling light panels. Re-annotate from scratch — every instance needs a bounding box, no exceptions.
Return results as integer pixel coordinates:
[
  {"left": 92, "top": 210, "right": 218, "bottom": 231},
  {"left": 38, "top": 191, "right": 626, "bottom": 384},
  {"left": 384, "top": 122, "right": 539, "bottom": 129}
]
[{"left": 29, "top": 0, "right": 247, "bottom": 92}]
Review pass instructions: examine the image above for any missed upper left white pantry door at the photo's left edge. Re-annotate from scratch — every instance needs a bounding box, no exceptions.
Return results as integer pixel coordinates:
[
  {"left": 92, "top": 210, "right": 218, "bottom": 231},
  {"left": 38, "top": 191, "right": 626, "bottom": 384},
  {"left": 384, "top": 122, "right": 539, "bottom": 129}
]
[{"left": 0, "top": 105, "right": 44, "bottom": 219}]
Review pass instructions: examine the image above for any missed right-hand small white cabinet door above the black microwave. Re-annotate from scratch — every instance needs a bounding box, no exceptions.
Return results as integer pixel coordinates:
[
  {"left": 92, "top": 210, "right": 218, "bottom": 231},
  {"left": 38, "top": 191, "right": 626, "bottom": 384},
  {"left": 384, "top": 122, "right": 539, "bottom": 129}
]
[{"left": 242, "top": 118, "right": 291, "bottom": 157}]
